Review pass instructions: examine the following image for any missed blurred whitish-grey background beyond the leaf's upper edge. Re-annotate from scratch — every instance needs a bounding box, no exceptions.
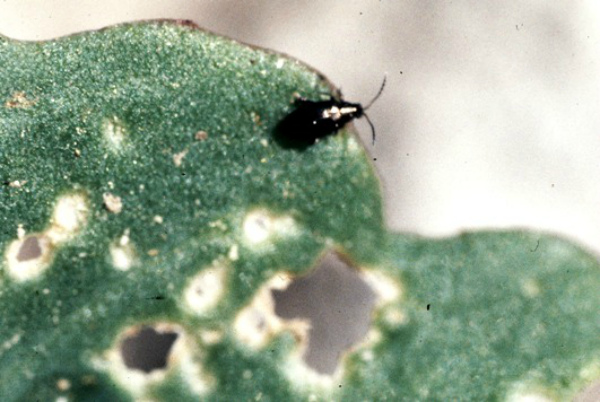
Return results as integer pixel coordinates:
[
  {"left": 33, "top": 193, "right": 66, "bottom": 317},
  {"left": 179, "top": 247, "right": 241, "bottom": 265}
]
[{"left": 0, "top": 0, "right": 600, "bottom": 255}]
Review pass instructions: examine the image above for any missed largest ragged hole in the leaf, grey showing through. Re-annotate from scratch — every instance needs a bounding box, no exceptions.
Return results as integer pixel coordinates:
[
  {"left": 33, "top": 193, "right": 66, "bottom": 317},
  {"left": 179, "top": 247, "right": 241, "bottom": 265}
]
[{"left": 272, "top": 253, "right": 376, "bottom": 374}]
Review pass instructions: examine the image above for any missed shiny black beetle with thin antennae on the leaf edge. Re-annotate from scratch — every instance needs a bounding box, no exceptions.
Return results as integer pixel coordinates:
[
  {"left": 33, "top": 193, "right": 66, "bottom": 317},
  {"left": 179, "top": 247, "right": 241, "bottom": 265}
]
[{"left": 276, "top": 77, "right": 386, "bottom": 149}]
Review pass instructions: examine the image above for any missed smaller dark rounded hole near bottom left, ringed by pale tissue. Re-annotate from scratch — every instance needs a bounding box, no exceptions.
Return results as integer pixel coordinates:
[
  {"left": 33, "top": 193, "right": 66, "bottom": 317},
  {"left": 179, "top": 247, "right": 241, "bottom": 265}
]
[{"left": 121, "top": 327, "right": 179, "bottom": 373}]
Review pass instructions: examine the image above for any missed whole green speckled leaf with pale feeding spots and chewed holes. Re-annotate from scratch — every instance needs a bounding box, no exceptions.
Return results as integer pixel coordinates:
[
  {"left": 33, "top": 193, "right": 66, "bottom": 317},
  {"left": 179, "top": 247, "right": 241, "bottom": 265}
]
[{"left": 0, "top": 22, "right": 600, "bottom": 401}]
